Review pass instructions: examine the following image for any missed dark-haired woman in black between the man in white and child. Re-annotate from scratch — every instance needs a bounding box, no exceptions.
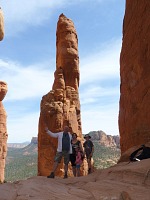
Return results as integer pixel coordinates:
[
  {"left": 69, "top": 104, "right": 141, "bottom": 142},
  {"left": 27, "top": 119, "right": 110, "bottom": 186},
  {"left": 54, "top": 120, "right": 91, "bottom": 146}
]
[{"left": 70, "top": 133, "right": 83, "bottom": 176}]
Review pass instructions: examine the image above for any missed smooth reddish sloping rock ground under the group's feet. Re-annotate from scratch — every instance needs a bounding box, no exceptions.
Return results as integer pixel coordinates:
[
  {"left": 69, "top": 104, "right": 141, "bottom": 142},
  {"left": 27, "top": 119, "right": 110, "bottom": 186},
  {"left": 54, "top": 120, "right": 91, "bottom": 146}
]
[{"left": 0, "top": 159, "right": 150, "bottom": 200}]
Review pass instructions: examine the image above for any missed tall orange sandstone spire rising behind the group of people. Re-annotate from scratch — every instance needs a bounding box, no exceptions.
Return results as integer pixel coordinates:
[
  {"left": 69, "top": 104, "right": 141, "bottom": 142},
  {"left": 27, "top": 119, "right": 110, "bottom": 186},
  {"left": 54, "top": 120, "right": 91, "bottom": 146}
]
[{"left": 38, "top": 14, "right": 82, "bottom": 175}]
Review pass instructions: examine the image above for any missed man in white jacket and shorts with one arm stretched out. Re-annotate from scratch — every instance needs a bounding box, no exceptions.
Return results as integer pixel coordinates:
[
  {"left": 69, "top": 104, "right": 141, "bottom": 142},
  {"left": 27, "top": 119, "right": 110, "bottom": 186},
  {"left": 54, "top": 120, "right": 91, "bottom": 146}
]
[{"left": 45, "top": 126, "right": 72, "bottom": 178}]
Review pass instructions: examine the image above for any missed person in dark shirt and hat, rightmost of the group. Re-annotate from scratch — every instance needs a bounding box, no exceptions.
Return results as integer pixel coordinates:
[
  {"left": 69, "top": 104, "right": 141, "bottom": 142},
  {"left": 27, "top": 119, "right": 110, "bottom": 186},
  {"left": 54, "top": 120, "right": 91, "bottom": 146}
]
[{"left": 83, "top": 134, "right": 94, "bottom": 174}]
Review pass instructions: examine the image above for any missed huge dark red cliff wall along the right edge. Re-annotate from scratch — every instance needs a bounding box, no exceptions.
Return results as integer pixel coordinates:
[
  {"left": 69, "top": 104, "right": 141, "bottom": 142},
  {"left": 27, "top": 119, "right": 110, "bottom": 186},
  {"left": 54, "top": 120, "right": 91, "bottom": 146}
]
[{"left": 119, "top": 0, "right": 150, "bottom": 153}]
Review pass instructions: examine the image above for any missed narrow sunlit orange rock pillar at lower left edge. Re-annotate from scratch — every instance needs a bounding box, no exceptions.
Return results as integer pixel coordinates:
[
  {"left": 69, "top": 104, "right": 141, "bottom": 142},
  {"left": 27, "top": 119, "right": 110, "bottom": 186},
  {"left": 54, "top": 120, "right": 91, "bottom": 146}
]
[{"left": 0, "top": 81, "right": 8, "bottom": 182}]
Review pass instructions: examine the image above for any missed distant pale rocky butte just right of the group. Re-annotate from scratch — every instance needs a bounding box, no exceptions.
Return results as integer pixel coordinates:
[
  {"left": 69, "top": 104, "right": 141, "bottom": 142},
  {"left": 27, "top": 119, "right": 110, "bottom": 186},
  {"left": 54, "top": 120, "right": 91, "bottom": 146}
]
[{"left": 89, "top": 131, "right": 120, "bottom": 148}]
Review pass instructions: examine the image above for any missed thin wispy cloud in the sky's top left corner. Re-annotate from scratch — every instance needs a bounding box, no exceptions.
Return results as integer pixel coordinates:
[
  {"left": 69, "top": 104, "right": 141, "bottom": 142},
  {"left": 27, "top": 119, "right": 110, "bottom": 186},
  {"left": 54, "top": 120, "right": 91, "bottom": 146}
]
[{"left": 1, "top": 0, "right": 118, "bottom": 37}]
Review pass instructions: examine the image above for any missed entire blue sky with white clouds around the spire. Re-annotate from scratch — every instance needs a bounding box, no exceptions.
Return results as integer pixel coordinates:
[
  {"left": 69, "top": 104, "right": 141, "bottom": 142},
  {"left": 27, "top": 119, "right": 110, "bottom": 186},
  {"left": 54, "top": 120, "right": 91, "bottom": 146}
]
[{"left": 0, "top": 0, "right": 125, "bottom": 142}]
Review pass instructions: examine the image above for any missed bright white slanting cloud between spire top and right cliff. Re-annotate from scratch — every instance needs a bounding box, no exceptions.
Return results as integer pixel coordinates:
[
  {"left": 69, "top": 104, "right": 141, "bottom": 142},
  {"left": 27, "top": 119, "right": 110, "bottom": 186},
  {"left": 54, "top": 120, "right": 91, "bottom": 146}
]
[{"left": 80, "top": 39, "right": 121, "bottom": 85}]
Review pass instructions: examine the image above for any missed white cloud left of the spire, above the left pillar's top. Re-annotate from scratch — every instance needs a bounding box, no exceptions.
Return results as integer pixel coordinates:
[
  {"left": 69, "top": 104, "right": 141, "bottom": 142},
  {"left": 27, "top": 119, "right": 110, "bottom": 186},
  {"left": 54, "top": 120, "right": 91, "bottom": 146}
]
[{"left": 0, "top": 60, "right": 54, "bottom": 101}]
